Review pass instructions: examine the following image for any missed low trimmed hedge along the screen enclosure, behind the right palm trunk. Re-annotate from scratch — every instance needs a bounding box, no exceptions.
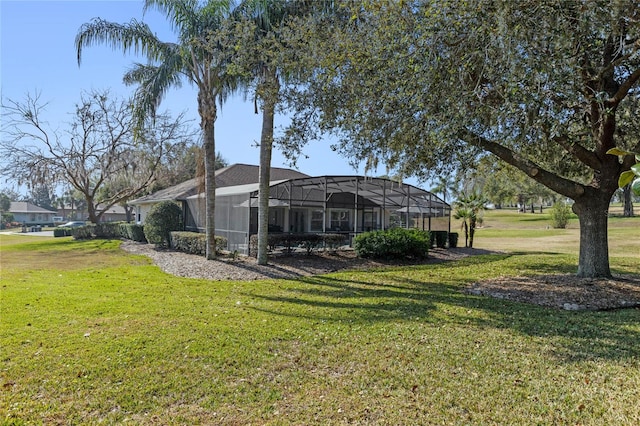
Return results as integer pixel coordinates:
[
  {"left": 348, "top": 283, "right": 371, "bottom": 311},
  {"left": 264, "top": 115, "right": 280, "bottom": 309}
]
[{"left": 249, "top": 233, "right": 347, "bottom": 257}]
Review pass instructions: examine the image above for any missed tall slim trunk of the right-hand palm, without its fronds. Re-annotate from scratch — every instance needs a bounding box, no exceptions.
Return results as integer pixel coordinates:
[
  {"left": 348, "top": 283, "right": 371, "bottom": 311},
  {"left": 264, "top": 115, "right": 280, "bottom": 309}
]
[{"left": 257, "top": 72, "right": 279, "bottom": 265}]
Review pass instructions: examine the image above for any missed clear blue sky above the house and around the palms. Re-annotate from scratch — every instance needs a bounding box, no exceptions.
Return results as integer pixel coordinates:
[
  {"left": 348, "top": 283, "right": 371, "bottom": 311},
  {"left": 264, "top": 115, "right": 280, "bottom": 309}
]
[{"left": 0, "top": 0, "right": 412, "bottom": 195}]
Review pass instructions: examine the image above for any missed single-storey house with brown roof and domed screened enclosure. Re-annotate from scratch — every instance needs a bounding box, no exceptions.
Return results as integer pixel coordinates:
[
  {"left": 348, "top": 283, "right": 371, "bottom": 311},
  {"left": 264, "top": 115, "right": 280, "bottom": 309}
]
[{"left": 129, "top": 164, "right": 451, "bottom": 254}]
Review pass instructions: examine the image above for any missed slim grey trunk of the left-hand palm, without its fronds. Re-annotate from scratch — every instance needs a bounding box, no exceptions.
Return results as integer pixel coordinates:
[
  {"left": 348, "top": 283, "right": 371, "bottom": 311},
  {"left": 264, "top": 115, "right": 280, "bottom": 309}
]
[{"left": 198, "top": 90, "right": 217, "bottom": 260}]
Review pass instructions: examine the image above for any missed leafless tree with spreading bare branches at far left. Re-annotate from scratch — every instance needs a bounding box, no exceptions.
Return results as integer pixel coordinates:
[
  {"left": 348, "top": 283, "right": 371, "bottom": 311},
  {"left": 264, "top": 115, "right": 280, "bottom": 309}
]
[{"left": 0, "top": 91, "right": 193, "bottom": 223}]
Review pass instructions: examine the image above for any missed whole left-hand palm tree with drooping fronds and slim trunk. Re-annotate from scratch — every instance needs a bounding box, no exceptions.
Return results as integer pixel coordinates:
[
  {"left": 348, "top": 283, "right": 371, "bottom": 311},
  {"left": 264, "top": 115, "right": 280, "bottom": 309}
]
[{"left": 75, "top": 0, "right": 237, "bottom": 259}]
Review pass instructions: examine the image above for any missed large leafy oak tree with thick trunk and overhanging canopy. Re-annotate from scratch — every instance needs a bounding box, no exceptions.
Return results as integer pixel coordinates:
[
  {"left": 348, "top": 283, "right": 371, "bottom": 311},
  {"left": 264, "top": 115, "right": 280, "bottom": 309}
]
[{"left": 282, "top": 0, "right": 640, "bottom": 277}]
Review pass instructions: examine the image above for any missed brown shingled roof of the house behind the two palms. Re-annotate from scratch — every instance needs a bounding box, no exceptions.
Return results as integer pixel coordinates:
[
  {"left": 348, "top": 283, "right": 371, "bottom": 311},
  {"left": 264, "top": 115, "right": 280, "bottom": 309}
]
[{"left": 129, "top": 164, "right": 309, "bottom": 204}]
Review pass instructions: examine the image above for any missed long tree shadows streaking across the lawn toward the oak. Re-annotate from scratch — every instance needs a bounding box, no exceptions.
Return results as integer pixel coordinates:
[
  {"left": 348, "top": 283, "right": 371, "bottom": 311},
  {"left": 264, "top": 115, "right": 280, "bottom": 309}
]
[{"left": 241, "top": 256, "right": 640, "bottom": 362}]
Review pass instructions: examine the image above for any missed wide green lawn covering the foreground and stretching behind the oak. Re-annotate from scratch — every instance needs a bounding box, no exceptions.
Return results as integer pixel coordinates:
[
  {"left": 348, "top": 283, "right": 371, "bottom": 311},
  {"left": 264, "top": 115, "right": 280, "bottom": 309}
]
[{"left": 0, "top": 212, "right": 640, "bottom": 425}]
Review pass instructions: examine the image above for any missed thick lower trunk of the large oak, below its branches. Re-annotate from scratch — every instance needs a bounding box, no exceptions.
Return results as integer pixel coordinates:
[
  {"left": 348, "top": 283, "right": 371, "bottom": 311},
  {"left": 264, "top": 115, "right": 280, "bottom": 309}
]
[{"left": 573, "top": 197, "right": 611, "bottom": 278}]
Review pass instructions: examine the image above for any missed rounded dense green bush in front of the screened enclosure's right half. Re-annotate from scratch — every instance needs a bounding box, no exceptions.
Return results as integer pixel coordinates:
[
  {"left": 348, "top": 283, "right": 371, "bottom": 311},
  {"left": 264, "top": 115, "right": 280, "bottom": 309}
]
[{"left": 354, "top": 228, "right": 430, "bottom": 259}]
